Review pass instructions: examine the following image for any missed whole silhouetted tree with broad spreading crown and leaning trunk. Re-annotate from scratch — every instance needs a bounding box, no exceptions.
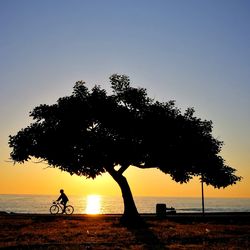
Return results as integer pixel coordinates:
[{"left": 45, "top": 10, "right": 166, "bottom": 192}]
[{"left": 9, "top": 74, "right": 241, "bottom": 225}]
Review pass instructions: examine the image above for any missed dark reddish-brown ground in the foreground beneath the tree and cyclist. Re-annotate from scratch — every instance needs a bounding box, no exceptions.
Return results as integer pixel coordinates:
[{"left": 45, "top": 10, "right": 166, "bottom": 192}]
[{"left": 0, "top": 212, "right": 250, "bottom": 250}]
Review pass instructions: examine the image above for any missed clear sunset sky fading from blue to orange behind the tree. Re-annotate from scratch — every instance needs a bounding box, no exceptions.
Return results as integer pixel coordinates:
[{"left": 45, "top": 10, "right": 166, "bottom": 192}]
[{"left": 0, "top": 0, "right": 250, "bottom": 197}]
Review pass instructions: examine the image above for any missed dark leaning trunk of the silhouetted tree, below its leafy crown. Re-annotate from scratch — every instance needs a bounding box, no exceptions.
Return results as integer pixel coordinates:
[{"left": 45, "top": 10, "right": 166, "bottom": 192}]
[{"left": 108, "top": 168, "right": 141, "bottom": 225}]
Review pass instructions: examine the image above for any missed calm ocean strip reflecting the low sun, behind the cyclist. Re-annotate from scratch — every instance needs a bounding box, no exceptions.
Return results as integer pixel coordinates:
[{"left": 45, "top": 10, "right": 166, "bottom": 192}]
[{"left": 0, "top": 194, "right": 250, "bottom": 214}]
